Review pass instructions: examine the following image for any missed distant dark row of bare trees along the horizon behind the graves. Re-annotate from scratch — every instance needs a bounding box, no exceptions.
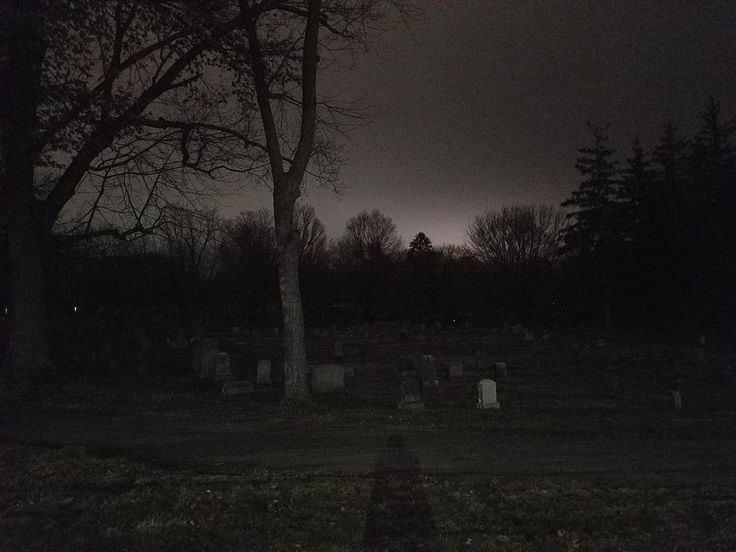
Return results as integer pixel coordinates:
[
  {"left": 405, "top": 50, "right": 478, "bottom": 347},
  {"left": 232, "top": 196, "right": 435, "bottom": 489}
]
[{"left": 18, "top": 204, "right": 563, "bottom": 327}]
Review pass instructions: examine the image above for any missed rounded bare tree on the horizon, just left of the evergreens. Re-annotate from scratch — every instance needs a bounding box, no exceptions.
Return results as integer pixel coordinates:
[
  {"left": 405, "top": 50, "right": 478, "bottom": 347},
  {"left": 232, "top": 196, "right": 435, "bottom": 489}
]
[{"left": 466, "top": 205, "right": 564, "bottom": 271}]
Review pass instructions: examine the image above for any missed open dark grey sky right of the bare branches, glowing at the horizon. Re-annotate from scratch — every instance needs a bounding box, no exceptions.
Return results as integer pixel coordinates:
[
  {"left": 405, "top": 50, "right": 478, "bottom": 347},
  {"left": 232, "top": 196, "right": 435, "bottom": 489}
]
[{"left": 223, "top": 0, "right": 736, "bottom": 245}]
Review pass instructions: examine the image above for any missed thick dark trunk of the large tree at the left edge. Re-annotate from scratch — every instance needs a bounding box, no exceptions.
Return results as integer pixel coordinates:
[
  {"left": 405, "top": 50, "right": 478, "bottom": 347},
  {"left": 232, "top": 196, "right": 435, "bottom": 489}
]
[{"left": 0, "top": 0, "right": 51, "bottom": 387}]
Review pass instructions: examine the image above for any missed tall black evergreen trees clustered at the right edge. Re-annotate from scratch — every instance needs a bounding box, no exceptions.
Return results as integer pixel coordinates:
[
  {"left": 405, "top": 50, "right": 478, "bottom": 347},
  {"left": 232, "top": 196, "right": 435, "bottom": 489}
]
[{"left": 562, "top": 98, "right": 736, "bottom": 327}]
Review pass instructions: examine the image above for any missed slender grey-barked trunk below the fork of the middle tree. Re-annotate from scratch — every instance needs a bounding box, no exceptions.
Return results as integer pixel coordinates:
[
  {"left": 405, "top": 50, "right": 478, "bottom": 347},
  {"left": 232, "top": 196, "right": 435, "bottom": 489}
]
[{"left": 274, "top": 192, "right": 309, "bottom": 404}]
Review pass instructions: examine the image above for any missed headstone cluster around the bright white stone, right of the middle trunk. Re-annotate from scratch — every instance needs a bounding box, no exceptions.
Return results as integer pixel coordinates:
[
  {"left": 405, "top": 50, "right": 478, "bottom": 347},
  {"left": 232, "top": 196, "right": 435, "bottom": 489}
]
[{"left": 399, "top": 355, "right": 508, "bottom": 410}]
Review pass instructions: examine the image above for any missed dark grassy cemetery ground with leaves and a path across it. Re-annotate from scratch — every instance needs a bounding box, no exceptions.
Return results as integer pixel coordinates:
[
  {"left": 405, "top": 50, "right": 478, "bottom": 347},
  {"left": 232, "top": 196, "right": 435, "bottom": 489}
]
[{"left": 0, "top": 327, "right": 736, "bottom": 551}]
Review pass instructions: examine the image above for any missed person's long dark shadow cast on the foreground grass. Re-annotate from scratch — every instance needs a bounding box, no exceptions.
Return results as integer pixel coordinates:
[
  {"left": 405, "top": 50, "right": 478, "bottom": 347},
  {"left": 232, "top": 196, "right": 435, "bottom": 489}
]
[{"left": 363, "top": 435, "right": 435, "bottom": 552}]
